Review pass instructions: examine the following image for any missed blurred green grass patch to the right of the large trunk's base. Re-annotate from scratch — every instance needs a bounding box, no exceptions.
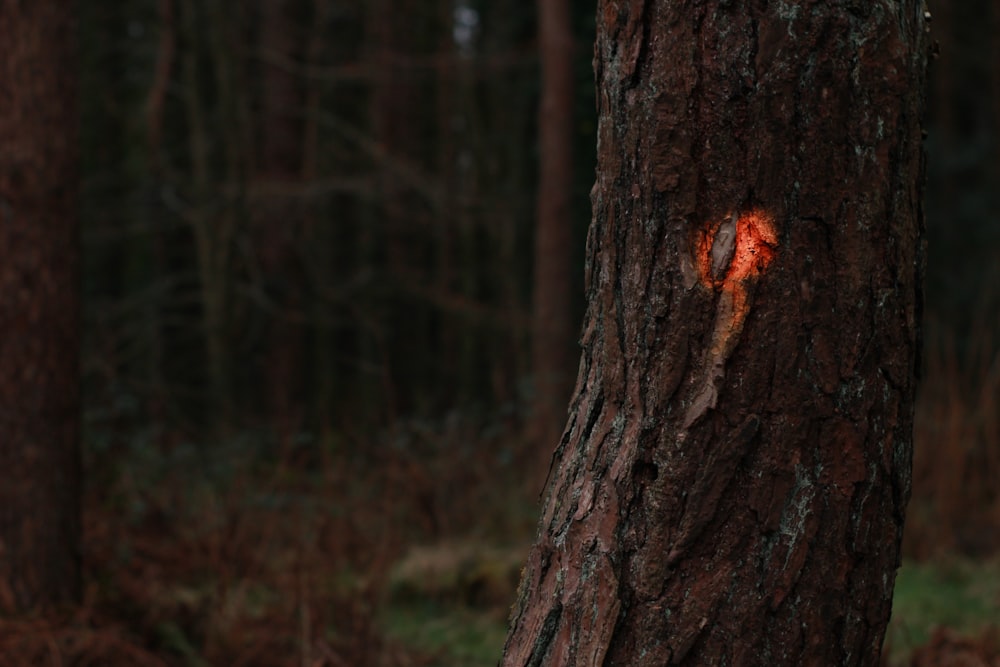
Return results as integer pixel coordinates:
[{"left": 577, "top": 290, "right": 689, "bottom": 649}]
[{"left": 886, "top": 561, "right": 1000, "bottom": 665}]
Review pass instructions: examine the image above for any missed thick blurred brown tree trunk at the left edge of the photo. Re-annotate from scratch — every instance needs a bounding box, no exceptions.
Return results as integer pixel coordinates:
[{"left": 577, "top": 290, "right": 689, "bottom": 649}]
[{"left": 0, "top": 0, "right": 80, "bottom": 611}]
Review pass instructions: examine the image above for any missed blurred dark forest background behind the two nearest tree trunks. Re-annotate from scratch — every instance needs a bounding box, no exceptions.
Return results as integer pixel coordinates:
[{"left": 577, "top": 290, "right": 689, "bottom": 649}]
[{"left": 7, "top": 0, "right": 1000, "bottom": 667}]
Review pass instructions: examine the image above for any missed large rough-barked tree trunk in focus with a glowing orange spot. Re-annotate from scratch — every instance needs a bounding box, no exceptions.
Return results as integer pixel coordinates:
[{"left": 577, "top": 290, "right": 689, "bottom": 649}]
[{"left": 503, "top": 0, "right": 928, "bottom": 666}]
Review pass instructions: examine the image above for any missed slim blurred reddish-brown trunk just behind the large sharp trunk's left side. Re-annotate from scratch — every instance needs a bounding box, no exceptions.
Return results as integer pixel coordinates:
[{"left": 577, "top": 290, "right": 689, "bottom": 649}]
[{"left": 532, "top": 0, "right": 573, "bottom": 486}]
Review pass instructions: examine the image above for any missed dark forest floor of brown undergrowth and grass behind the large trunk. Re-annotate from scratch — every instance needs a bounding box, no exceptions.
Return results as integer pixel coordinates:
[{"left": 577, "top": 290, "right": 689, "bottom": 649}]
[{"left": 0, "top": 384, "right": 1000, "bottom": 667}]
